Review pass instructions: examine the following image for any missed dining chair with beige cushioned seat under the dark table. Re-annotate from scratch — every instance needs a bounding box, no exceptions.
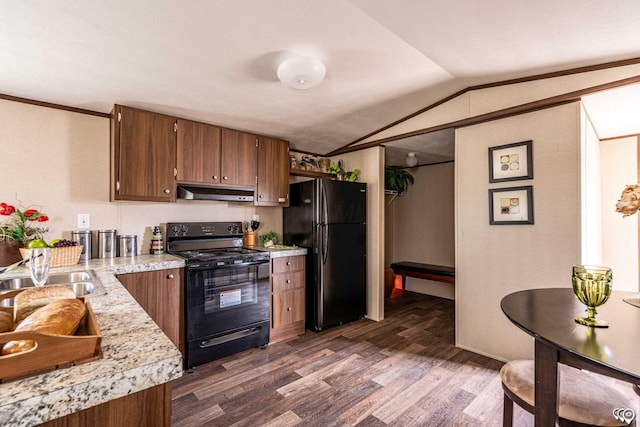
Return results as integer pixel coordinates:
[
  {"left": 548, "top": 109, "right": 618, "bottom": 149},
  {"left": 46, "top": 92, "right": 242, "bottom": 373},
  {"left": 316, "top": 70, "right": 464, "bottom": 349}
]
[{"left": 500, "top": 360, "right": 638, "bottom": 427}]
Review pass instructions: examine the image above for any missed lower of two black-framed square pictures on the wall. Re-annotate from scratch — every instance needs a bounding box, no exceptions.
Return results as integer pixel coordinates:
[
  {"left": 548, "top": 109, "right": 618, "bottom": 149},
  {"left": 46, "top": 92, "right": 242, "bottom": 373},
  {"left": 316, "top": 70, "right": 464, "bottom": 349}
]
[{"left": 489, "top": 185, "right": 533, "bottom": 225}]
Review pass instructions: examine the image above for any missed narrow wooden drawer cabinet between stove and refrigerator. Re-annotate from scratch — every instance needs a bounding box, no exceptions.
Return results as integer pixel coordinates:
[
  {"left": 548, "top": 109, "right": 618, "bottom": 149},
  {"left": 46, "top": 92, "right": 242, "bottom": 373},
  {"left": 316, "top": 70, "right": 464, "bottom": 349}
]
[{"left": 269, "top": 255, "right": 305, "bottom": 342}]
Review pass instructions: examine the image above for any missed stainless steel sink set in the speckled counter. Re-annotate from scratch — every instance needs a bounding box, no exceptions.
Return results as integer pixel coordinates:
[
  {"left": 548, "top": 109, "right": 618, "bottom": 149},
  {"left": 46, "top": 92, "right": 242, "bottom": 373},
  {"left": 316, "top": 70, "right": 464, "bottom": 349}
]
[{"left": 0, "top": 270, "right": 105, "bottom": 304}]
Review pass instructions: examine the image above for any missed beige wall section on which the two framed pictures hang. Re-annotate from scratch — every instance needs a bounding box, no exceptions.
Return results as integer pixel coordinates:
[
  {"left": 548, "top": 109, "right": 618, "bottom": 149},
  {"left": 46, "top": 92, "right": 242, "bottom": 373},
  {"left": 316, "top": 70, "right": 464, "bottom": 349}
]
[{"left": 455, "top": 103, "right": 581, "bottom": 360}]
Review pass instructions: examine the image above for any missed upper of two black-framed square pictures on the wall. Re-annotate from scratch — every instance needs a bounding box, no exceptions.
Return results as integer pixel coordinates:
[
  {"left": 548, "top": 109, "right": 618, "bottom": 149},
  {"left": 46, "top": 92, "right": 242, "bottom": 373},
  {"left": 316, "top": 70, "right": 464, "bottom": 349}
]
[{"left": 489, "top": 140, "right": 533, "bottom": 182}]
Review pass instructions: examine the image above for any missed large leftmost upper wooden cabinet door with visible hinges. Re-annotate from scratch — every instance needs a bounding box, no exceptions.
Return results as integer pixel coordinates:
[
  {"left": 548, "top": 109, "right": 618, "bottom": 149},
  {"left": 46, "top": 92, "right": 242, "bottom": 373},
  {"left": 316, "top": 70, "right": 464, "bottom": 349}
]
[{"left": 111, "top": 105, "right": 176, "bottom": 202}]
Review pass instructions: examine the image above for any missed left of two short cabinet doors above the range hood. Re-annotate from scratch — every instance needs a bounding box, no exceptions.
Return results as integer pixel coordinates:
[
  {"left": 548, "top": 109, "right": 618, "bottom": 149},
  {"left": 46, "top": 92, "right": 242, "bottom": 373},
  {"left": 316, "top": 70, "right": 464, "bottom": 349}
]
[{"left": 176, "top": 119, "right": 221, "bottom": 184}]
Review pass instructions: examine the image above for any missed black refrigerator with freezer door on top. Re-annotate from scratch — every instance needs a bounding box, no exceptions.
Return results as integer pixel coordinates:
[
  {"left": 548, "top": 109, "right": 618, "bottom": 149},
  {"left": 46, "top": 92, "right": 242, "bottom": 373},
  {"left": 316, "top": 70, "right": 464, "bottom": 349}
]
[{"left": 283, "top": 179, "right": 367, "bottom": 331}]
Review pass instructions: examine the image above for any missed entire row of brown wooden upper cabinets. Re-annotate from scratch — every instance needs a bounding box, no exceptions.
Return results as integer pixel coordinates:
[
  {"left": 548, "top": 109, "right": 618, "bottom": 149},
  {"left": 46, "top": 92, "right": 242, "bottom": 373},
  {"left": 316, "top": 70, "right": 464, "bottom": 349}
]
[{"left": 111, "top": 105, "right": 289, "bottom": 206}]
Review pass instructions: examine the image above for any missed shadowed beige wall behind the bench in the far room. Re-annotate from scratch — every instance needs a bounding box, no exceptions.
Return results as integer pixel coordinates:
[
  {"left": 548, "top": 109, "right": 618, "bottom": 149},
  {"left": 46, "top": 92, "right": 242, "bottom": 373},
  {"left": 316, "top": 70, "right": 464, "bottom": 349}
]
[{"left": 387, "top": 163, "right": 455, "bottom": 299}]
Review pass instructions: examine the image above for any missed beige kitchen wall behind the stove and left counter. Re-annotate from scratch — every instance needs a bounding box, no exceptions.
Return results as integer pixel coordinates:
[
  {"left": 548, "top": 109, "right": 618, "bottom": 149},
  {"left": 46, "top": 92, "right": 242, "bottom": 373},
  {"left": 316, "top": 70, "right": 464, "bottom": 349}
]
[{"left": 0, "top": 100, "right": 282, "bottom": 253}]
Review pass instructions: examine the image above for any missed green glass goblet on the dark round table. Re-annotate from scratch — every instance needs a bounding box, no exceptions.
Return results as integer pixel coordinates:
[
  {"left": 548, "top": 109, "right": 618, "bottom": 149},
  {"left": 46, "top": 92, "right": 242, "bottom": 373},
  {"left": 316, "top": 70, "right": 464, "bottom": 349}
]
[{"left": 571, "top": 265, "right": 612, "bottom": 328}]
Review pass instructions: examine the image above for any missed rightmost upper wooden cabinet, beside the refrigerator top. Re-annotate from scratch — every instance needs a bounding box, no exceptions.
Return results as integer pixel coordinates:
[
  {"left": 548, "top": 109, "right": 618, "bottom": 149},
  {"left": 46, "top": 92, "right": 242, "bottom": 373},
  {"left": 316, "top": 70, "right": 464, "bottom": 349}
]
[{"left": 254, "top": 137, "right": 289, "bottom": 206}]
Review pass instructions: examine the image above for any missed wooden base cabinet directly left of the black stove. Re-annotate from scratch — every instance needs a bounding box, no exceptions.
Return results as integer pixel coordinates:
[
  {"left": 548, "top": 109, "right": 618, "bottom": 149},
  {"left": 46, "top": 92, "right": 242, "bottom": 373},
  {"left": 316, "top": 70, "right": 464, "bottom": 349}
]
[{"left": 116, "top": 268, "right": 184, "bottom": 354}]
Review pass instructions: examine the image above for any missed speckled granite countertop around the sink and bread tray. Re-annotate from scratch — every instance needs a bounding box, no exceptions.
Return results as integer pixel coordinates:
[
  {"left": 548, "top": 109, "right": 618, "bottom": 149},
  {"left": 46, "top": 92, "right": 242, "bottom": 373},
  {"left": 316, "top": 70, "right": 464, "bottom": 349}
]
[{"left": 0, "top": 255, "right": 184, "bottom": 426}]
